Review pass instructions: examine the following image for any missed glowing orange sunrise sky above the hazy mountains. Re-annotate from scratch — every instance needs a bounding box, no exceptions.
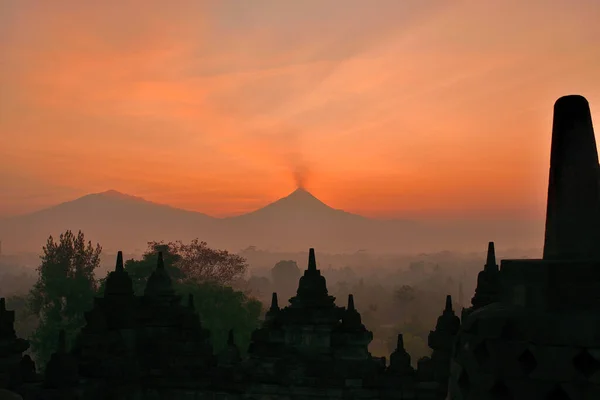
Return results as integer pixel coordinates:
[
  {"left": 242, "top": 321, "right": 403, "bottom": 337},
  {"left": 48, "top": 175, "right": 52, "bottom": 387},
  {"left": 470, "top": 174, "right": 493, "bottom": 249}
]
[{"left": 0, "top": 0, "right": 600, "bottom": 218}]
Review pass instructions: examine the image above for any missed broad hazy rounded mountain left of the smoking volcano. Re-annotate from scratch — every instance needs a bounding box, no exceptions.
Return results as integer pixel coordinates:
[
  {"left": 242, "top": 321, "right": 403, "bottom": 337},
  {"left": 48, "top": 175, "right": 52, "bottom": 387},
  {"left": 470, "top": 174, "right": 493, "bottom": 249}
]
[{"left": 0, "top": 190, "right": 216, "bottom": 251}]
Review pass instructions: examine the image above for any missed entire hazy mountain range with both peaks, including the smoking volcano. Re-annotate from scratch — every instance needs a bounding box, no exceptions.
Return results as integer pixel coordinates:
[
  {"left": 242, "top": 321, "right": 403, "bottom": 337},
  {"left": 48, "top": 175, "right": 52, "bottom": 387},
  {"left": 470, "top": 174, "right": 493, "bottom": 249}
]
[{"left": 0, "top": 189, "right": 543, "bottom": 253}]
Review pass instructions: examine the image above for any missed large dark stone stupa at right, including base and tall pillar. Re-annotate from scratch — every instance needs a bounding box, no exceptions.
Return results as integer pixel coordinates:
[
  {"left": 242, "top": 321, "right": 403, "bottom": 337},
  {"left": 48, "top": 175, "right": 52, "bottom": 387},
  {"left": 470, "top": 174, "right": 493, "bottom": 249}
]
[{"left": 449, "top": 96, "right": 600, "bottom": 400}]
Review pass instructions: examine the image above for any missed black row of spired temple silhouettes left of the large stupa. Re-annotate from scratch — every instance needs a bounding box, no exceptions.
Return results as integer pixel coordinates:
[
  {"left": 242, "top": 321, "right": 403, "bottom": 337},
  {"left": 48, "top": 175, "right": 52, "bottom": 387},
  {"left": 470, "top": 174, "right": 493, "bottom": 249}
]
[{"left": 0, "top": 249, "right": 458, "bottom": 400}]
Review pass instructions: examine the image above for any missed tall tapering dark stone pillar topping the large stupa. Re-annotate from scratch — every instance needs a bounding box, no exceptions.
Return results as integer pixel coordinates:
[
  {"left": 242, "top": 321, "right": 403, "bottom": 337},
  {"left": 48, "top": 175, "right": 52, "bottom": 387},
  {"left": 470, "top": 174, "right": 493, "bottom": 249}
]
[{"left": 544, "top": 96, "right": 600, "bottom": 260}]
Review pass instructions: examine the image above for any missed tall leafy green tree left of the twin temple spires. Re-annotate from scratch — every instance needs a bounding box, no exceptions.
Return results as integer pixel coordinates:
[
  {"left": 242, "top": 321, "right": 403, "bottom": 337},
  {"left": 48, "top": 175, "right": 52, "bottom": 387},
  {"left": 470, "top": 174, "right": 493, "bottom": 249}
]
[{"left": 29, "top": 230, "right": 102, "bottom": 368}]
